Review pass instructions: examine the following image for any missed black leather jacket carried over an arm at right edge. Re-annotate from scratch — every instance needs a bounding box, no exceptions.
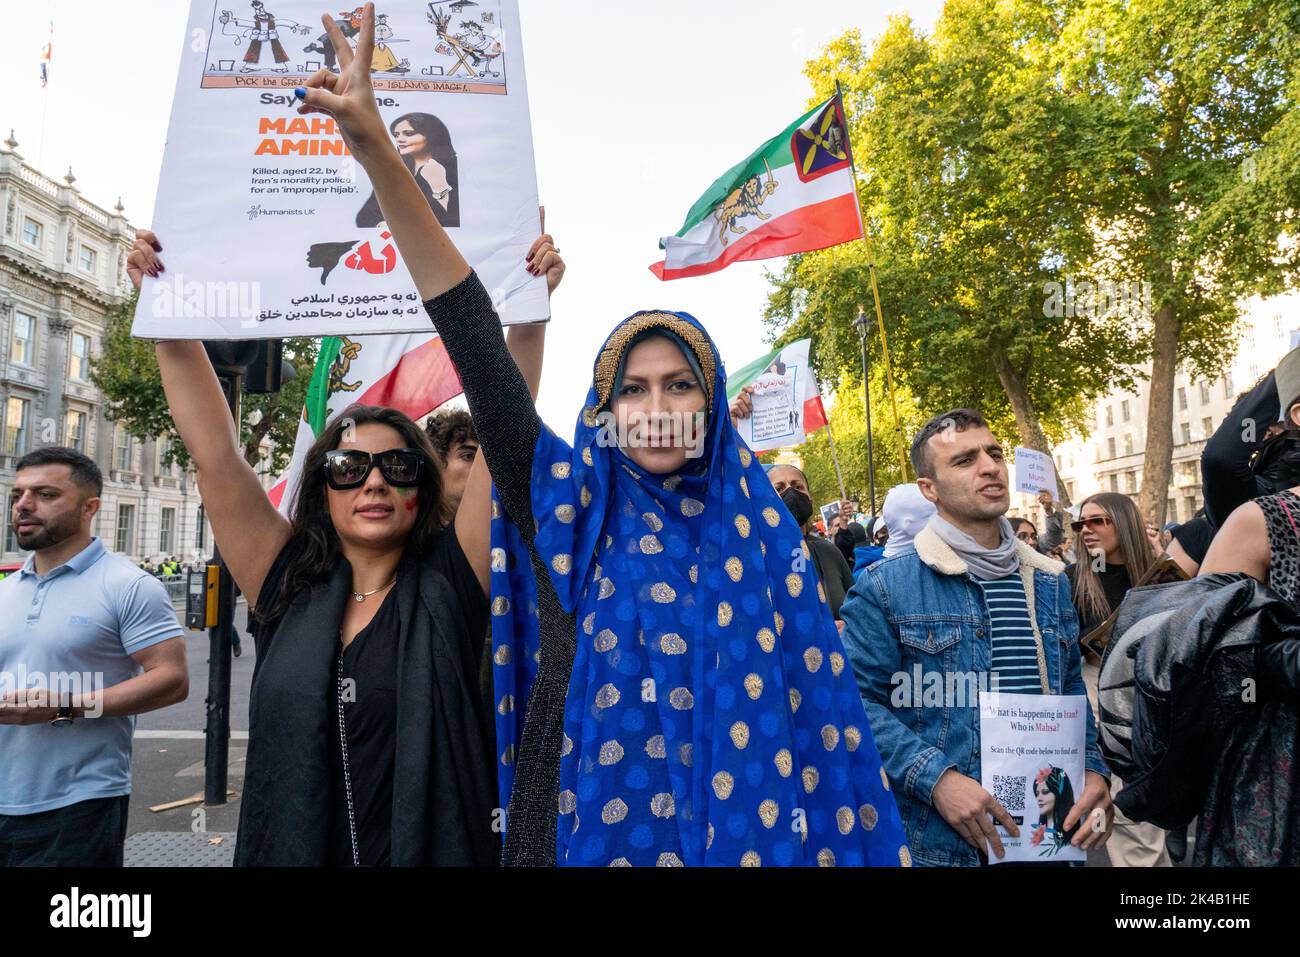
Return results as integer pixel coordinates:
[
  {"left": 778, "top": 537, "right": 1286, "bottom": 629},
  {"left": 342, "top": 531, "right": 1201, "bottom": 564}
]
[{"left": 1097, "top": 575, "right": 1300, "bottom": 828}]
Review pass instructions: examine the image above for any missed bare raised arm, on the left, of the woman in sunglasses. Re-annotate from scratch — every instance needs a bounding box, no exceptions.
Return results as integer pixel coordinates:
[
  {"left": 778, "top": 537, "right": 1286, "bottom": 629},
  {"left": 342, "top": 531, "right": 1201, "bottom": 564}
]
[{"left": 126, "top": 229, "right": 290, "bottom": 605}]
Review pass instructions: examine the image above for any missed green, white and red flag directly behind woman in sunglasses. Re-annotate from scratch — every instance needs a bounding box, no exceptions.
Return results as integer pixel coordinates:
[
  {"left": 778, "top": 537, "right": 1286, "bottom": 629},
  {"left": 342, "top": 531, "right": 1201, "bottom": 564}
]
[{"left": 268, "top": 333, "right": 463, "bottom": 515}]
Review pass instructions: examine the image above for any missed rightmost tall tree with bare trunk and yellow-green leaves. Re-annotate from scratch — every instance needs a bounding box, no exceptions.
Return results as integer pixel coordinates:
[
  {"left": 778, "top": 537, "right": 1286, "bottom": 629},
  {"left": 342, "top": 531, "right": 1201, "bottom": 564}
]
[{"left": 1052, "top": 0, "right": 1300, "bottom": 525}]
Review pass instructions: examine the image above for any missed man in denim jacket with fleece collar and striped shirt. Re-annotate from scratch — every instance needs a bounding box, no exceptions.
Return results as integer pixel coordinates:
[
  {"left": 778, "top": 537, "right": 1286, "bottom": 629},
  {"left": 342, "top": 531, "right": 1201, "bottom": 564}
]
[{"left": 841, "top": 410, "right": 1113, "bottom": 866}]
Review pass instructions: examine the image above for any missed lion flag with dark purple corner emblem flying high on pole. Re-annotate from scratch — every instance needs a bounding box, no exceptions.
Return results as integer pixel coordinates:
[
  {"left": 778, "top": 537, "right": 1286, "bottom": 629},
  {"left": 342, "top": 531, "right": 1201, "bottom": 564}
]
[{"left": 650, "top": 94, "right": 862, "bottom": 280}]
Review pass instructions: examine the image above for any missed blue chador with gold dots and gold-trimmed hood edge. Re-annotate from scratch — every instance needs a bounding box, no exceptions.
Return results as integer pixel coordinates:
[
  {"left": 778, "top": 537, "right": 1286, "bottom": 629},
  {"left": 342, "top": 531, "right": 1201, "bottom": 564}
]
[{"left": 491, "top": 312, "right": 910, "bottom": 866}]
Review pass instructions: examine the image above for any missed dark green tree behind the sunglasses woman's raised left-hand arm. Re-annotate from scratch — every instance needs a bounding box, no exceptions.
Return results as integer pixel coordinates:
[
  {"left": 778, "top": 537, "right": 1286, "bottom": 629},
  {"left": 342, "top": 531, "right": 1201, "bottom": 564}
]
[{"left": 91, "top": 287, "right": 319, "bottom": 475}]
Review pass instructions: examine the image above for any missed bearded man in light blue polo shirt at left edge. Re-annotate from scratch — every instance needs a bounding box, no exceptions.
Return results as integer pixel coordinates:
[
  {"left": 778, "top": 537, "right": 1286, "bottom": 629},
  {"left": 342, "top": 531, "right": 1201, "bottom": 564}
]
[{"left": 0, "top": 447, "right": 190, "bottom": 867}]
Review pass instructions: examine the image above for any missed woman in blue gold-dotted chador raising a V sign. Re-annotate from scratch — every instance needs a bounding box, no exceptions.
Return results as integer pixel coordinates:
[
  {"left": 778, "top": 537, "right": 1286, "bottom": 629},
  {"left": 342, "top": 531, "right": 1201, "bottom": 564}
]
[{"left": 296, "top": 7, "right": 910, "bottom": 866}]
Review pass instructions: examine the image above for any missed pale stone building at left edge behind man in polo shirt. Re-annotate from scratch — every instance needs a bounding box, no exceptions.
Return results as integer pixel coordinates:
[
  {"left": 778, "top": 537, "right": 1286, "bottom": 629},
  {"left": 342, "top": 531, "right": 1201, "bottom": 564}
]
[{"left": 0, "top": 133, "right": 212, "bottom": 567}]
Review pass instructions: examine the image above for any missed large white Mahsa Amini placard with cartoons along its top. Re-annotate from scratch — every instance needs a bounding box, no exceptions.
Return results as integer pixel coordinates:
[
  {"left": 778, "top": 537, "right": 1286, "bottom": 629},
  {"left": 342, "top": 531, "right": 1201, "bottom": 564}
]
[{"left": 133, "top": 0, "right": 550, "bottom": 339}]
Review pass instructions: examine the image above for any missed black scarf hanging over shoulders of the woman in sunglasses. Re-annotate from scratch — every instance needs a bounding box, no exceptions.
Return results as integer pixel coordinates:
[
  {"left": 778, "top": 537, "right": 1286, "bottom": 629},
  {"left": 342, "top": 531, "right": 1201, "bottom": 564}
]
[{"left": 235, "top": 538, "right": 501, "bottom": 866}]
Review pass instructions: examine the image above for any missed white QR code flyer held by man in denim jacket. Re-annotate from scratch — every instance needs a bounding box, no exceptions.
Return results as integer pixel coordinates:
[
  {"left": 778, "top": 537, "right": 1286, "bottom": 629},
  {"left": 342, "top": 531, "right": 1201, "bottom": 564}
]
[{"left": 979, "top": 692, "right": 1088, "bottom": 863}]
